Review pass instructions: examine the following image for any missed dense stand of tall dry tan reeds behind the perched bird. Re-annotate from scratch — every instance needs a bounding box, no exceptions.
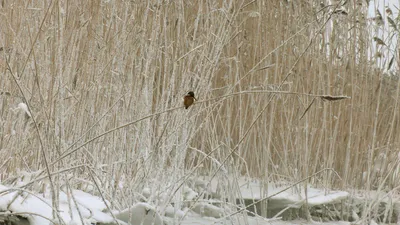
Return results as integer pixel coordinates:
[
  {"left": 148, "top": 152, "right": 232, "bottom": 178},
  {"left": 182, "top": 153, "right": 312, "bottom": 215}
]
[{"left": 0, "top": 0, "right": 400, "bottom": 221}]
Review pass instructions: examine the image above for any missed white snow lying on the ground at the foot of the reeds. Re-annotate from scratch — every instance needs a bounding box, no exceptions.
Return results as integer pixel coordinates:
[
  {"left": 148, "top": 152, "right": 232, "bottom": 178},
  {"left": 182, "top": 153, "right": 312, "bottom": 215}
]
[{"left": 0, "top": 178, "right": 397, "bottom": 225}]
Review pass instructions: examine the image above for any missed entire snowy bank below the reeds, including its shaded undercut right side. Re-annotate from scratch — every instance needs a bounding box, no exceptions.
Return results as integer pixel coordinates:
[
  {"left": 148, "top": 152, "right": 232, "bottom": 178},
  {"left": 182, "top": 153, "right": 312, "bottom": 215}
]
[{"left": 0, "top": 174, "right": 399, "bottom": 225}]
